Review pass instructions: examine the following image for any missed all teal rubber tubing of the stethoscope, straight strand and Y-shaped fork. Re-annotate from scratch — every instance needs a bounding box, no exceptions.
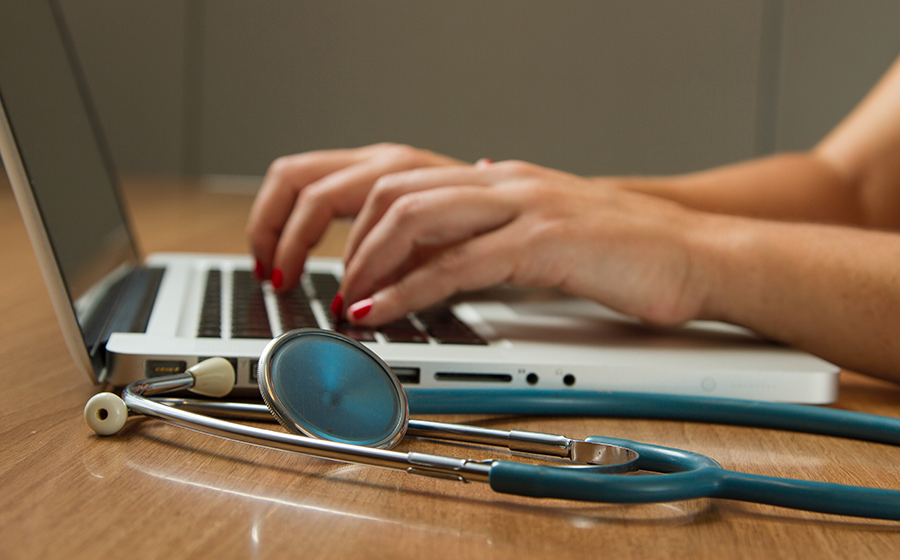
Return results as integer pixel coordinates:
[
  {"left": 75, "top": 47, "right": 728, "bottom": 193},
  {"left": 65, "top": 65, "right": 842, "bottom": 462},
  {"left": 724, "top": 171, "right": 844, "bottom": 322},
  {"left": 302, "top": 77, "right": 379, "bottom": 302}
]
[{"left": 407, "top": 389, "right": 900, "bottom": 520}]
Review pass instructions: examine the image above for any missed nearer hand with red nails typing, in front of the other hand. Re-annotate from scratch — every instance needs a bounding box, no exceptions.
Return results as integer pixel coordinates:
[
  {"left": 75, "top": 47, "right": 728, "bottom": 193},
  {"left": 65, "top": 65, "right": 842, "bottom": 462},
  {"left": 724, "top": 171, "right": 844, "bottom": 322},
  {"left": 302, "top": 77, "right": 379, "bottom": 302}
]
[{"left": 340, "top": 161, "right": 707, "bottom": 325}]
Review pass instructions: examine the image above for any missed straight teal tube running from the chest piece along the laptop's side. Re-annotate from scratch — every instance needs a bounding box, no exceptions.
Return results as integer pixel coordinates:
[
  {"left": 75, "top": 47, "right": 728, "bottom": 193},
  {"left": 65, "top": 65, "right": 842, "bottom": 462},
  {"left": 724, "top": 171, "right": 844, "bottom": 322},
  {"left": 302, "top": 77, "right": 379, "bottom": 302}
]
[{"left": 406, "top": 389, "right": 900, "bottom": 445}]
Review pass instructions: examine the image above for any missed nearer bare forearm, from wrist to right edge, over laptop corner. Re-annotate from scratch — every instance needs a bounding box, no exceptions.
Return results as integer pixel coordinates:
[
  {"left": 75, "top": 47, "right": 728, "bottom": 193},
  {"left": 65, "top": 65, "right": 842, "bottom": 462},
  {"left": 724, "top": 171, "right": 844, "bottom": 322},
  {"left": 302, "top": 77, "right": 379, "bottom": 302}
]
[{"left": 694, "top": 212, "right": 900, "bottom": 381}]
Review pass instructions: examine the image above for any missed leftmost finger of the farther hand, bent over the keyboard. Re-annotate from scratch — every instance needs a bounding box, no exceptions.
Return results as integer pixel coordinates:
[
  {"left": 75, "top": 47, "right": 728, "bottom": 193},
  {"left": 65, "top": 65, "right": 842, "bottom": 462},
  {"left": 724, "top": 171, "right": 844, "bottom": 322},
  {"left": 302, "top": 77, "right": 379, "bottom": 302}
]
[{"left": 247, "top": 147, "right": 380, "bottom": 277}]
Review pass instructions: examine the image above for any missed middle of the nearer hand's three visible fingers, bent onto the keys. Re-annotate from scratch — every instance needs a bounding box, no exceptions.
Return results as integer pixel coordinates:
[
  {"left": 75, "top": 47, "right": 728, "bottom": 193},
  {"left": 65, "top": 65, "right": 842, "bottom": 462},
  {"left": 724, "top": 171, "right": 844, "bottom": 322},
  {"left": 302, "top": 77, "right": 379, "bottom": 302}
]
[{"left": 341, "top": 187, "right": 517, "bottom": 310}]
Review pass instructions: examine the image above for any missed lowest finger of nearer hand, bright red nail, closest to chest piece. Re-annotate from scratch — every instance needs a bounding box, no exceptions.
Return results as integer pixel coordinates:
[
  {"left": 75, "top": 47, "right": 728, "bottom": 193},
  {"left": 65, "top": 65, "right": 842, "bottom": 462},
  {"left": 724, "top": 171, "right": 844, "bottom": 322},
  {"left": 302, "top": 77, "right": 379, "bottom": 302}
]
[{"left": 347, "top": 227, "right": 523, "bottom": 326}]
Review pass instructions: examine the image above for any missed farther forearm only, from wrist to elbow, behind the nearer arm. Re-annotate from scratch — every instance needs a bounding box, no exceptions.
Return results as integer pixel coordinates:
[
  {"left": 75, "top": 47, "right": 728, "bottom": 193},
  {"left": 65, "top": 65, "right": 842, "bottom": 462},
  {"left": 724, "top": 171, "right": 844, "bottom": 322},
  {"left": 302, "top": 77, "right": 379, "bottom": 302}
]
[{"left": 612, "top": 152, "right": 863, "bottom": 225}]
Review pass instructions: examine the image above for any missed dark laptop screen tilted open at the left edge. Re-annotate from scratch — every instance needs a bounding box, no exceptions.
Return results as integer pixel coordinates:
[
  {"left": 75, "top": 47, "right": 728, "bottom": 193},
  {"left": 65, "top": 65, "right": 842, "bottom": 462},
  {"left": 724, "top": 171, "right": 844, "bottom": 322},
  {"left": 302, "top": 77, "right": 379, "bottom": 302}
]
[{"left": 0, "top": 0, "right": 137, "bottom": 370}]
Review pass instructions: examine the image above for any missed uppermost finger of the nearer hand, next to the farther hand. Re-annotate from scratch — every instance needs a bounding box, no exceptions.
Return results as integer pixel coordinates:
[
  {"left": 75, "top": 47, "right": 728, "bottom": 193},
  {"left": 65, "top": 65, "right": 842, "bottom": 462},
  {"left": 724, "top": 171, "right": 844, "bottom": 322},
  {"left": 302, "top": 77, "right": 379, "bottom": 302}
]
[{"left": 343, "top": 165, "right": 508, "bottom": 264}]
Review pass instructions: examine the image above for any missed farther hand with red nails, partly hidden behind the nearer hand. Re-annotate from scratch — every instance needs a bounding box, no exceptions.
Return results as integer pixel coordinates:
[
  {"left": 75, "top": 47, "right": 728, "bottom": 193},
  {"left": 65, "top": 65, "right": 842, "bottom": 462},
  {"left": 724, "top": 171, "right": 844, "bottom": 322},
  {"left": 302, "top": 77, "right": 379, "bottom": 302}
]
[{"left": 247, "top": 144, "right": 462, "bottom": 291}]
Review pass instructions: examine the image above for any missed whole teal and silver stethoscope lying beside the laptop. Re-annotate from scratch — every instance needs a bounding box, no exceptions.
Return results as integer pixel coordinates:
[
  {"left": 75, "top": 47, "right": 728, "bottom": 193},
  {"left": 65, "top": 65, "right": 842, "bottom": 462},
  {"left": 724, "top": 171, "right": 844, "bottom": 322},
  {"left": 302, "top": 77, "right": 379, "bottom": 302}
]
[{"left": 84, "top": 329, "right": 900, "bottom": 520}]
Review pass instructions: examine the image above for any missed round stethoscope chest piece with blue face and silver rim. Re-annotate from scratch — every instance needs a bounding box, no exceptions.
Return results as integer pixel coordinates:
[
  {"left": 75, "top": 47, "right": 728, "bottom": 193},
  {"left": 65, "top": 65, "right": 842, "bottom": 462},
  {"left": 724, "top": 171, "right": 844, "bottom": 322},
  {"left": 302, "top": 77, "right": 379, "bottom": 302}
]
[{"left": 257, "top": 329, "right": 409, "bottom": 449}]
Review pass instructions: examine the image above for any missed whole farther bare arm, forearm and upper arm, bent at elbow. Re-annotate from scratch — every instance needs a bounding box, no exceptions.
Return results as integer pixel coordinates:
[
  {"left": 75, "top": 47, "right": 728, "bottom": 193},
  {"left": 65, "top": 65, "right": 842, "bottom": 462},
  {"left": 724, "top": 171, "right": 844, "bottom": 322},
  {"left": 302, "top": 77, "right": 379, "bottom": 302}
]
[{"left": 624, "top": 50, "right": 900, "bottom": 229}]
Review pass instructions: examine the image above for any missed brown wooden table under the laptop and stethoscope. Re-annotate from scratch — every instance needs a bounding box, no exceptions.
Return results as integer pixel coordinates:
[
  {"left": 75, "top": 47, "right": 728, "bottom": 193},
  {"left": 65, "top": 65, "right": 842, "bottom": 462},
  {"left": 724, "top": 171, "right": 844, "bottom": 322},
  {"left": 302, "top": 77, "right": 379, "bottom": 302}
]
[{"left": 0, "top": 176, "right": 900, "bottom": 560}]
